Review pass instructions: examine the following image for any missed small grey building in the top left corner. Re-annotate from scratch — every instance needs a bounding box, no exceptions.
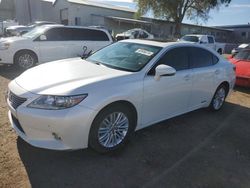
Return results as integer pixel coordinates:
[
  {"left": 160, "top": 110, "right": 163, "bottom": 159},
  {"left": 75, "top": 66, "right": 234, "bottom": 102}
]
[{"left": 0, "top": 0, "right": 16, "bottom": 21}]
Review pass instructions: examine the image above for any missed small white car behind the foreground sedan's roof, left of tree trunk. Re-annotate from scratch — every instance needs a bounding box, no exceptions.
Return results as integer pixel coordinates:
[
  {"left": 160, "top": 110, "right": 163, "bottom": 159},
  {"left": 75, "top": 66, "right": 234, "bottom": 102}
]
[{"left": 115, "top": 28, "right": 154, "bottom": 41}]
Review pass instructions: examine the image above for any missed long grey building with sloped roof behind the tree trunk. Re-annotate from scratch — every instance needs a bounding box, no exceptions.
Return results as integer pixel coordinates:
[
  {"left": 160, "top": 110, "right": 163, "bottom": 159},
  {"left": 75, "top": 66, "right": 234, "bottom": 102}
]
[{"left": 50, "top": 0, "right": 232, "bottom": 42}]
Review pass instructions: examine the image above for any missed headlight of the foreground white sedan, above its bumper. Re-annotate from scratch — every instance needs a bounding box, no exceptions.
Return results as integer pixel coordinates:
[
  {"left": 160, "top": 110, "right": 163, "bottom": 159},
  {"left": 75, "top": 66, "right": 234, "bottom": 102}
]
[{"left": 27, "top": 94, "right": 88, "bottom": 110}]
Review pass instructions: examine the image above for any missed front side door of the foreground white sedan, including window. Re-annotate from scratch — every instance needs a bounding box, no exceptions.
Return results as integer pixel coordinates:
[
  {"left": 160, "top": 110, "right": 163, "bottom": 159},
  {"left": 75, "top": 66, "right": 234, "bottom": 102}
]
[{"left": 142, "top": 47, "right": 193, "bottom": 127}]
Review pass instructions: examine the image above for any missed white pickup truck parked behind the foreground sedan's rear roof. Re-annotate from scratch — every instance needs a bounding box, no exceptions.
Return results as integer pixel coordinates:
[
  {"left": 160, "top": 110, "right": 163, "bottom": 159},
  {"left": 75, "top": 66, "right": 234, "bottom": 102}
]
[{"left": 178, "top": 35, "right": 225, "bottom": 54}]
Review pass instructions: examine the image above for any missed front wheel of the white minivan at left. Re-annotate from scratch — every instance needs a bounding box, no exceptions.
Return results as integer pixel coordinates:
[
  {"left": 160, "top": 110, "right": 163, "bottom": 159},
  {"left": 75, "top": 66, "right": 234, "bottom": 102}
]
[{"left": 14, "top": 51, "right": 37, "bottom": 70}]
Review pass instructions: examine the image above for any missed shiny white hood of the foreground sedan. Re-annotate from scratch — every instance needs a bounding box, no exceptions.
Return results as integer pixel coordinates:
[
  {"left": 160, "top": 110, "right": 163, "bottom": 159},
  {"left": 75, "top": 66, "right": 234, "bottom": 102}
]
[{"left": 15, "top": 58, "right": 131, "bottom": 95}]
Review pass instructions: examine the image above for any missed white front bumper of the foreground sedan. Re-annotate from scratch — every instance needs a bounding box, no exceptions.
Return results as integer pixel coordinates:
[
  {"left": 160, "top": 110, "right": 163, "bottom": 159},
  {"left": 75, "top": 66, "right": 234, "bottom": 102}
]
[{"left": 7, "top": 81, "right": 96, "bottom": 150}]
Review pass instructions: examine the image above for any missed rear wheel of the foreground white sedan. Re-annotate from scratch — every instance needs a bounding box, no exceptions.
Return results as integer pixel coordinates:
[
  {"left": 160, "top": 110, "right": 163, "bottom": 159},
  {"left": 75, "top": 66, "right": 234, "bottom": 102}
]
[{"left": 209, "top": 85, "right": 227, "bottom": 111}]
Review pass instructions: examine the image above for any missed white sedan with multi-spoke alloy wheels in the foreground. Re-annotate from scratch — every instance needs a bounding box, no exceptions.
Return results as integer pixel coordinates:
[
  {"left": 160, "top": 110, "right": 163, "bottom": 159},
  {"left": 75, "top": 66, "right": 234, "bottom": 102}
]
[{"left": 7, "top": 40, "right": 235, "bottom": 152}]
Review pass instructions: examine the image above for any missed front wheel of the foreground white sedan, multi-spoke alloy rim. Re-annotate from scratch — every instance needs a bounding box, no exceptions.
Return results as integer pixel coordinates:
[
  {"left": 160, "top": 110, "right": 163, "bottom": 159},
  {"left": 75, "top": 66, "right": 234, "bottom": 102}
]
[{"left": 89, "top": 105, "right": 136, "bottom": 153}]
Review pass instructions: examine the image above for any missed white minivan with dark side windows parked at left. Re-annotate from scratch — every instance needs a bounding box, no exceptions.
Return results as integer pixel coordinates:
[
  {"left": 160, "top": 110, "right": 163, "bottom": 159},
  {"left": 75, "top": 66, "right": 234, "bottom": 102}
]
[{"left": 0, "top": 25, "right": 113, "bottom": 69}]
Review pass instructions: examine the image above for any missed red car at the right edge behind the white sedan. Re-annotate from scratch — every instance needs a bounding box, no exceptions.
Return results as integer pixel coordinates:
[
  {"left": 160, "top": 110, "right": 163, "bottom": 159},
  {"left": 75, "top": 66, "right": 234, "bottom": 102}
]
[{"left": 229, "top": 49, "right": 250, "bottom": 87}]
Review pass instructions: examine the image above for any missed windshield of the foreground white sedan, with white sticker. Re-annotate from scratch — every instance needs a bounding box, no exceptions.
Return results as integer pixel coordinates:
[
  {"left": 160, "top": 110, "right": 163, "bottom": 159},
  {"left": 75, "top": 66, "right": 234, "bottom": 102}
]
[{"left": 86, "top": 42, "right": 162, "bottom": 72}]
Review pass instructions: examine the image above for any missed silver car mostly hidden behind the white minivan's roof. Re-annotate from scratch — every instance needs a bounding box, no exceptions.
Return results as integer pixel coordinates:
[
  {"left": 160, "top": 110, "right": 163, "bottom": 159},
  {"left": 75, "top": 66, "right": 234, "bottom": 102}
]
[{"left": 4, "top": 21, "right": 56, "bottom": 37}]
